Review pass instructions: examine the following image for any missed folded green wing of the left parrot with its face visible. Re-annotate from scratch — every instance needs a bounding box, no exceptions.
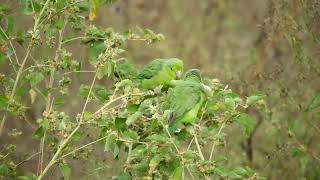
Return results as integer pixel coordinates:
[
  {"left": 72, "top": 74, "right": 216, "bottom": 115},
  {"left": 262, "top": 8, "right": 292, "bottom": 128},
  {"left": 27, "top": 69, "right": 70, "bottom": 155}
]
[{"left": 137, "top": 59, "right": 164, "bottom": 80}]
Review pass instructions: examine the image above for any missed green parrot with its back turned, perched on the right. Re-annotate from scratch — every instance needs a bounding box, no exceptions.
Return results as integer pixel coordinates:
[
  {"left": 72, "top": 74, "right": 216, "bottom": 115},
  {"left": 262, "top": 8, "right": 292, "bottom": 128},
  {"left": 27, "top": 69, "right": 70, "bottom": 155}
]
[{"left": 167, "top": 69, "right": 212, "bottom": 132}]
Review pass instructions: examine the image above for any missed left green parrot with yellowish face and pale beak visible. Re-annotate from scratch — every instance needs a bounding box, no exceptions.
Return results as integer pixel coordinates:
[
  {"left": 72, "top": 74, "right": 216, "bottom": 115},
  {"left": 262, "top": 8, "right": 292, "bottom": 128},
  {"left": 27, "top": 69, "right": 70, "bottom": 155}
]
[{"left": 137, "top": 58, "right": 183, "bottom": 89}]
